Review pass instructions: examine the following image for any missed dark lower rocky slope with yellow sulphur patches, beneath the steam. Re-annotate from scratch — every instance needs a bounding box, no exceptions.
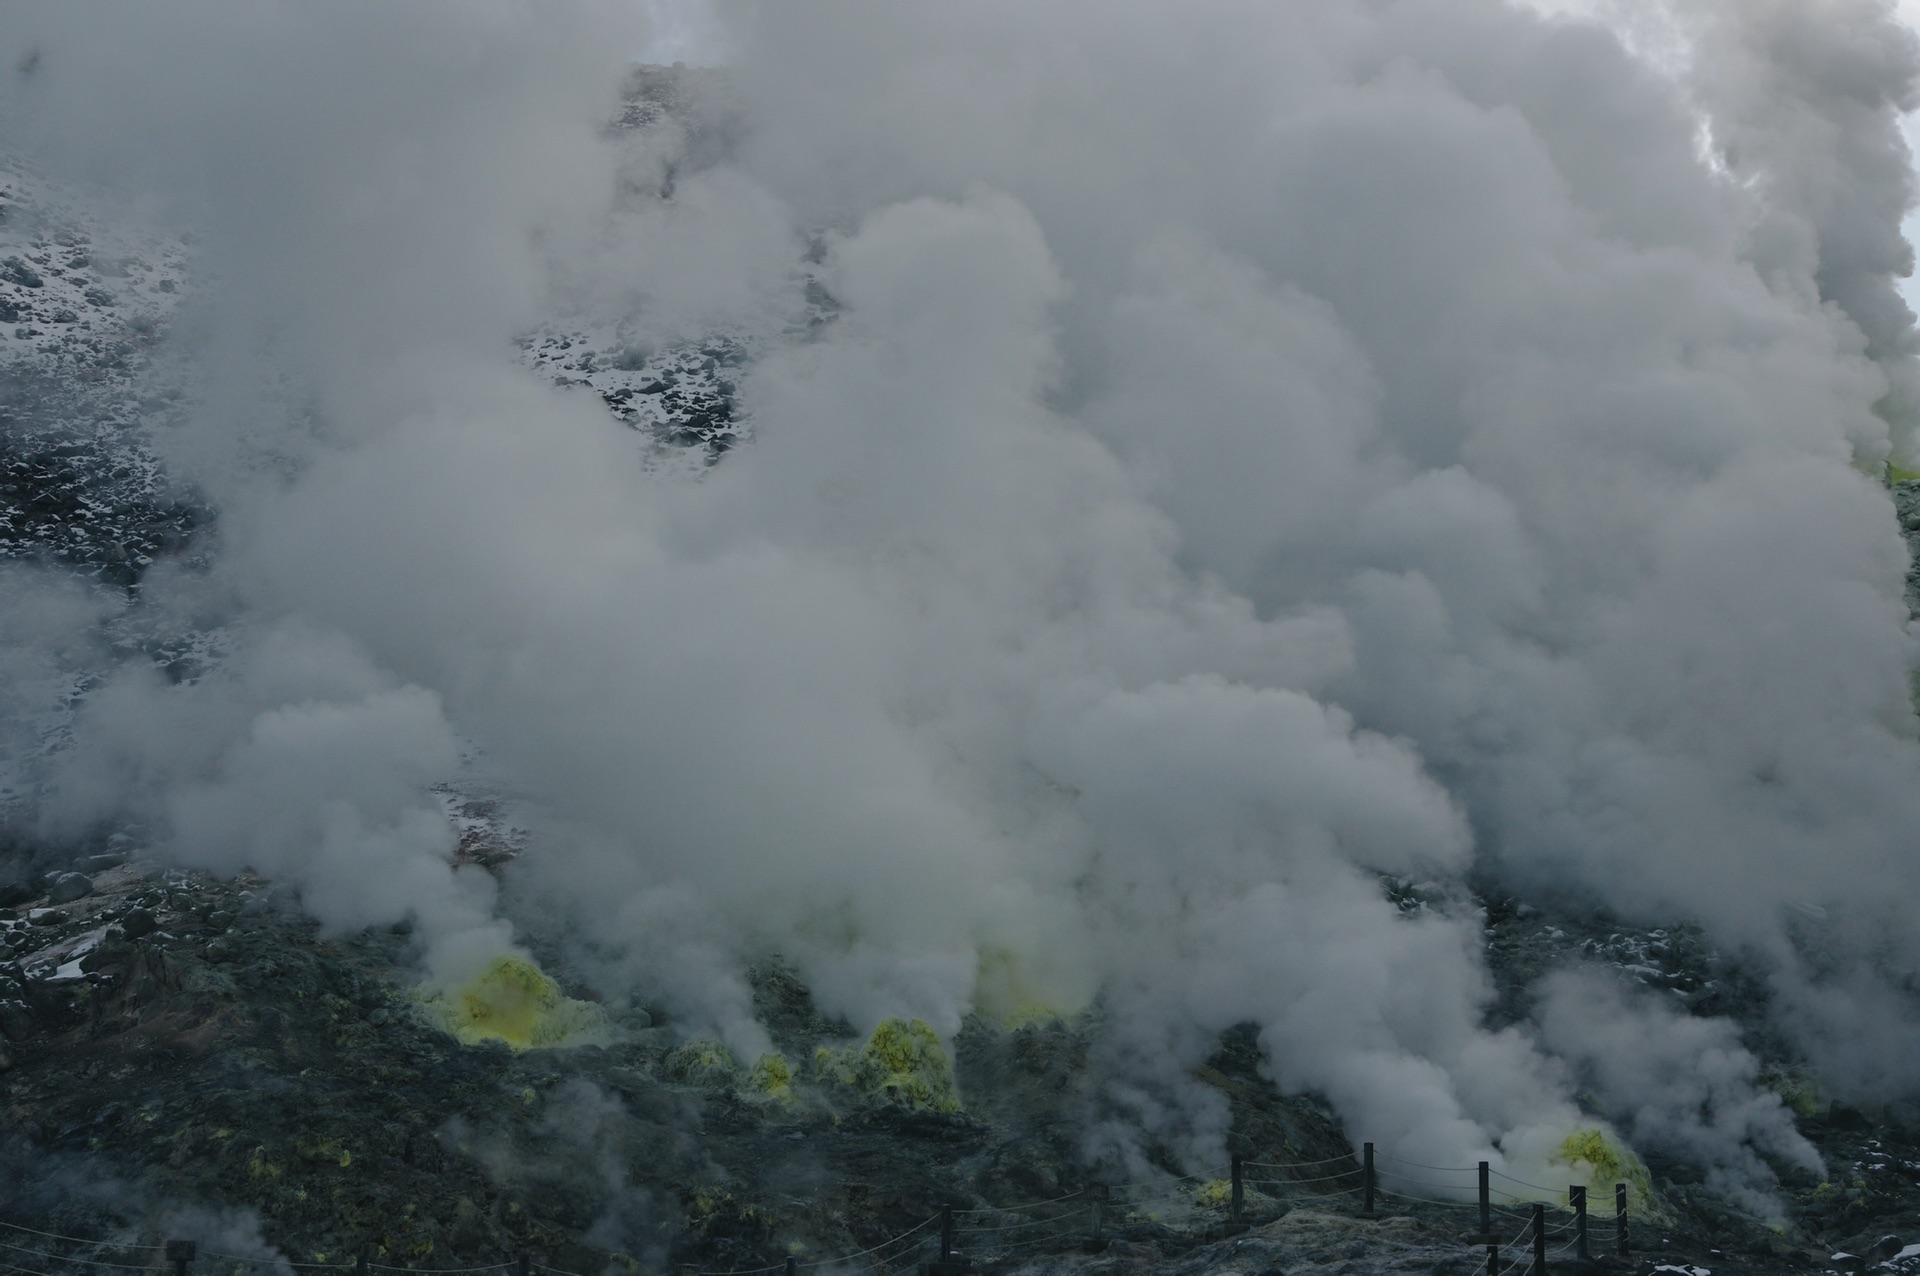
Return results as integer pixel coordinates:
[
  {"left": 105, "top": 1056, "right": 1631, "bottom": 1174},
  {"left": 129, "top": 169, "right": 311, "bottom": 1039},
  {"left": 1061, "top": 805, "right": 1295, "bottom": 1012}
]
[{"left": 0, "top": 842, "right": 1920, "bottom": 1272}]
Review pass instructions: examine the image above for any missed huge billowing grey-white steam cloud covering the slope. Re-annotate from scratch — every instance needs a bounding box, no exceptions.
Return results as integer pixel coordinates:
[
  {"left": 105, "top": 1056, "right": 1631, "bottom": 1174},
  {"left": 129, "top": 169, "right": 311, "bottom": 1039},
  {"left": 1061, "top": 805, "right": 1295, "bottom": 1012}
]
[{"left": 0, "top": 0, "right": 1920, "bottom": 1251}]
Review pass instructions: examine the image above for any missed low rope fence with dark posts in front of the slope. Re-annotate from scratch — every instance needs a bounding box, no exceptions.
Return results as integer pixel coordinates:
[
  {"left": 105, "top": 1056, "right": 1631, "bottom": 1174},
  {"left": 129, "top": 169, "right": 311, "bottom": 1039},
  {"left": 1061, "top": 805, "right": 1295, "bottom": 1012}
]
[{"left": 0, "top": 1144, "right": 1630, "bottom": 1276}]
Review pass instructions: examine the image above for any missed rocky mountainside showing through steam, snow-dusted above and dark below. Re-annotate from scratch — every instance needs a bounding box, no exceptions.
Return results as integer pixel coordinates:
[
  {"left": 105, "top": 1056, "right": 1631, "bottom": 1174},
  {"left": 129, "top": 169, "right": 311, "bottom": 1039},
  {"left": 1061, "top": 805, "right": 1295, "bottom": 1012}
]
[{"left": 0, "top": 119, "right": 1920, "bottom": 1274}]
